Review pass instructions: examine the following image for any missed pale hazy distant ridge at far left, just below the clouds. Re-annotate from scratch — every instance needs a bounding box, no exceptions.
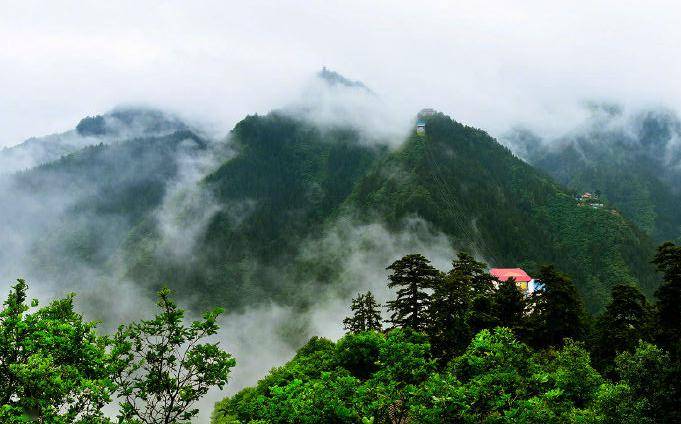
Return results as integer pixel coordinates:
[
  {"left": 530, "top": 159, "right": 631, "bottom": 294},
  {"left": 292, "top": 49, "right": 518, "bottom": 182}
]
[{"left": 0, "top": 107, "right": 189, "bottom": 174}]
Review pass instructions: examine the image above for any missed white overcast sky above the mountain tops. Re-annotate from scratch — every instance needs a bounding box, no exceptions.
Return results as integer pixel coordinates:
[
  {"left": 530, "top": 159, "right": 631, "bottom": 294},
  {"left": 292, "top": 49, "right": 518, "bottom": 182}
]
[{"left": 0, "top": 0, "right": 681, "bottom": 146}]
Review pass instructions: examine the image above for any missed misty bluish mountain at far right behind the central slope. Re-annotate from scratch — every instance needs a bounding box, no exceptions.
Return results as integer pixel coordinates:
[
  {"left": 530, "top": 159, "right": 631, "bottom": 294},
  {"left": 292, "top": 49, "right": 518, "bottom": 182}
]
[{"left": 504, "top": 105, "right": 681, "bottom": 242}]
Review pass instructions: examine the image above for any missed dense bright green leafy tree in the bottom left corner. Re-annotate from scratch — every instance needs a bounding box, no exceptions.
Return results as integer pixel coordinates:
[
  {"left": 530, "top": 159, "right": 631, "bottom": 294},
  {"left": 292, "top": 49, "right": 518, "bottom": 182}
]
[{"left": 0, "top": 280, "right": 114, "bottom": 424}]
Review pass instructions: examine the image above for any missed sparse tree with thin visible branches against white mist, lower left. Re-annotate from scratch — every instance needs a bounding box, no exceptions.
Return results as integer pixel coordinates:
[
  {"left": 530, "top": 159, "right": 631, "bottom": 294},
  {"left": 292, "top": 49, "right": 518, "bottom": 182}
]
[{"left": 113, "top": 288, "right": 236, "bottom": 424}]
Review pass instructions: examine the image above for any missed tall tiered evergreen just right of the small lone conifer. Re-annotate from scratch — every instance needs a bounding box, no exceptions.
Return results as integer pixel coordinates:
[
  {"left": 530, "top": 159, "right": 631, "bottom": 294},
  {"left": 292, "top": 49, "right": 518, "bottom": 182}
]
[{"left": 387, "top": 254, "right": 441, "bottom": 331}]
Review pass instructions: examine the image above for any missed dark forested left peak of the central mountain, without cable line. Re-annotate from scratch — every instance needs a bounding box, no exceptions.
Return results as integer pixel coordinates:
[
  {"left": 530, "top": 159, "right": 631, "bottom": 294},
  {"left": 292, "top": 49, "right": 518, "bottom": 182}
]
[{"left": 122, "top": 113, "right": 387, "bottom": 307}]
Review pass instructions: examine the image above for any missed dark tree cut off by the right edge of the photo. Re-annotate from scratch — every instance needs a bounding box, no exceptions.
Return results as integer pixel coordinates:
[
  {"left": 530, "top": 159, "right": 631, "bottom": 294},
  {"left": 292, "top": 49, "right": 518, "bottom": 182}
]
[{"left": 653, "top": 242, "right": 681, "bottom": 358}]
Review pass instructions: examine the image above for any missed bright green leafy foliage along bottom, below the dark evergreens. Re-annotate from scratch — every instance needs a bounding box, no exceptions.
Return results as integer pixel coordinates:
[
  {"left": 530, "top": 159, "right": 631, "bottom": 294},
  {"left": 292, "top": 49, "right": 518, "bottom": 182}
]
[{"left": 223, "top": 328, "right": 649, "bottom": 424}]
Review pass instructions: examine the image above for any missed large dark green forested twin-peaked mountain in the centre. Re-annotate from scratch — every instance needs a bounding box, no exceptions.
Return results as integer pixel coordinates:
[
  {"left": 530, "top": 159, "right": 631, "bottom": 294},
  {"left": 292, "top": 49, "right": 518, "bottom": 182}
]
[{"left": 123, "top": 112, "right": 657, "bottom": 310}]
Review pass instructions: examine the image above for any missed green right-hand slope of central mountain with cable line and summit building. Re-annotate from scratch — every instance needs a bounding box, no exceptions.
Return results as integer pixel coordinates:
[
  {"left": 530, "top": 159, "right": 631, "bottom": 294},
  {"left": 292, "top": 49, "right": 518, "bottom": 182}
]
[{"left": 347, "top": 115, "right": 656, "bottom": 309}]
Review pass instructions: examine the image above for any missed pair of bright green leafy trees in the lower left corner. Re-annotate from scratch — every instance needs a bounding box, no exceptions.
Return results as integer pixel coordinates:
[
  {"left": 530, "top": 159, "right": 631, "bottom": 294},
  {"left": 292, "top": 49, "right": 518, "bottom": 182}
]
[{"left": 0, "top": 280, "right": 235, "bottom": 424}]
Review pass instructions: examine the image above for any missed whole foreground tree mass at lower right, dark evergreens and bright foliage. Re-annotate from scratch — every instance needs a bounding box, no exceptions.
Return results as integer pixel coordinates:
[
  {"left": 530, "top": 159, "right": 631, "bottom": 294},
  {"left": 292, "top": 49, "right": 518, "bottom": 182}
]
[{"left": 213, "top": 243, "right": 681, "bottom": 424}]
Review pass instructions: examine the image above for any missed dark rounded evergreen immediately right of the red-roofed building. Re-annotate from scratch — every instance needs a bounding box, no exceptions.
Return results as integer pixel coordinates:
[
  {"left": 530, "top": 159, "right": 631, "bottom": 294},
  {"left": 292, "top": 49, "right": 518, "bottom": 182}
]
[{"left": 529, "top": 265, "right": 587, "bottom": 348}]
